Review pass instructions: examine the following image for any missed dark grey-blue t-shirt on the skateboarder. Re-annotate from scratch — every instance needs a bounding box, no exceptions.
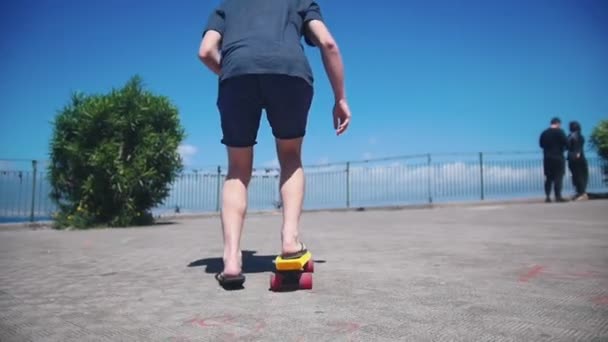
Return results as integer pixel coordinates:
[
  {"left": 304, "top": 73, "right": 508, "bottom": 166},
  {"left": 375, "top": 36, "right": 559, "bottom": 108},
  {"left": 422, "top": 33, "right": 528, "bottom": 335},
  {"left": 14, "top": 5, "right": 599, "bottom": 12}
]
[{"left": 203, "top": 0, "right": 322, "bottom": 84}]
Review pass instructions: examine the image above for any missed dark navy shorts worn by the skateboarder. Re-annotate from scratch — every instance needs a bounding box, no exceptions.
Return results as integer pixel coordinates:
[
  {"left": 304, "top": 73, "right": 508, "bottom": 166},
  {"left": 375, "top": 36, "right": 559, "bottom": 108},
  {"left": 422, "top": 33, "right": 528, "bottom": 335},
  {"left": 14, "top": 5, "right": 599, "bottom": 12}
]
[{"left": 217, "top": 74, "right": 313, "bottom": 147}]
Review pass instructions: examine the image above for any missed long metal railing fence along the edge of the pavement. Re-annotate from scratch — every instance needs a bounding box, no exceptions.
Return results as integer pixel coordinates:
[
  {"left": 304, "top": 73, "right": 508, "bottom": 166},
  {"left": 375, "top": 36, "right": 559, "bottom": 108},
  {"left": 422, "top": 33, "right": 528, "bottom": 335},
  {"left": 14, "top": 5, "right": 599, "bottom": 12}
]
[{"left": 0, "top": 152, "right": 608, "bottom": 222}]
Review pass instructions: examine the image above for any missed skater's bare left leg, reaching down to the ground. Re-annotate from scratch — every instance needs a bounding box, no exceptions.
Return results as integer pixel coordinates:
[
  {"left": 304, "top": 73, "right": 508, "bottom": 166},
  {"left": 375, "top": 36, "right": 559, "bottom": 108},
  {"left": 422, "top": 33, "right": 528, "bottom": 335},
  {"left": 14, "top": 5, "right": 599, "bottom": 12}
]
[{"left": 222, "top": 147, "right": 253, "bottom": 276}]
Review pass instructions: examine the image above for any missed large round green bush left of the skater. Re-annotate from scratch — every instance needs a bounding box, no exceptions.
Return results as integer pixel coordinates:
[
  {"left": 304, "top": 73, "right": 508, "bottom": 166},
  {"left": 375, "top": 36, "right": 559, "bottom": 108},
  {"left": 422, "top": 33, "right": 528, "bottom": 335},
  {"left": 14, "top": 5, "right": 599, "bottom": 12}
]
[{"left": 49, "top": 76, "right": 184, "bottom": 228}]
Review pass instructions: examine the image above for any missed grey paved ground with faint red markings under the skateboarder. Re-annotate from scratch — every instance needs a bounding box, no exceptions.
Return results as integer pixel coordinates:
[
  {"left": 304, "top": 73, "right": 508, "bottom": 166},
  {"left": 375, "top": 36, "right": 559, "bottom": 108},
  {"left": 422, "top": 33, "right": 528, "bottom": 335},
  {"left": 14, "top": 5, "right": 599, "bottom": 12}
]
[{"left": 0, "top": 201, "right": 608, "bottom": 342}]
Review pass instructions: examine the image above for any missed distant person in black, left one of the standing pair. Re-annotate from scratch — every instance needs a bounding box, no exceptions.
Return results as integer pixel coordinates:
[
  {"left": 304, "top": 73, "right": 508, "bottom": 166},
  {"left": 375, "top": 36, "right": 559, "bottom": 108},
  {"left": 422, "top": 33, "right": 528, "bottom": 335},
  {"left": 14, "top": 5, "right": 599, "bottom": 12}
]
[{"left": 539, "top": 118, "right": 568, "bottom": 203}]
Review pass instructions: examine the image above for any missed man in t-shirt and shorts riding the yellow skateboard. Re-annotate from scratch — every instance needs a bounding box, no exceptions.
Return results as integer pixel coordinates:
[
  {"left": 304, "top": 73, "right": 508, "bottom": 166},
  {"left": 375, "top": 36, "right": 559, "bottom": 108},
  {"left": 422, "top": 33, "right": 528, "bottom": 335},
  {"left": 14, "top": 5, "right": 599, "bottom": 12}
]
[{"left": 199, "top": 0, "right": 351, "bottom": 286}]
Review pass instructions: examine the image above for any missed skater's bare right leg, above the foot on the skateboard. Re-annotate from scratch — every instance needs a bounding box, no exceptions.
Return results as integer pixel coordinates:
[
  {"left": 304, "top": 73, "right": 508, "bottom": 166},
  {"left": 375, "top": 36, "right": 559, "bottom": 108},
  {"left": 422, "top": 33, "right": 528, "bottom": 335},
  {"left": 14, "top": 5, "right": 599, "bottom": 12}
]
[{"left": 276, "top": 138, "right": 305, "bottom": 253}]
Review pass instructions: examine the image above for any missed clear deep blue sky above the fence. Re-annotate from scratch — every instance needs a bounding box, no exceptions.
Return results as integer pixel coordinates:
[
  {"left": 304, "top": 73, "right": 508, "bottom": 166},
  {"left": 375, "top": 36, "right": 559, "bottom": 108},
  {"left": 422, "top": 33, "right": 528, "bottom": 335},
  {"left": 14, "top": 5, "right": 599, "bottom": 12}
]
[{"left": 0, "top": 0, "right": 608, "bottom": 166}]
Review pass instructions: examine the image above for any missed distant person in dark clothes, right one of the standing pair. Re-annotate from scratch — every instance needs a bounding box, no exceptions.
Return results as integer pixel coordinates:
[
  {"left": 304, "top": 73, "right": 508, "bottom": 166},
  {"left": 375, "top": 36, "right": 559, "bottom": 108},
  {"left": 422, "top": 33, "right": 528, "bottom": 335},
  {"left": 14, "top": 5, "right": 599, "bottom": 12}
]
[{"left": 568, "top": 121, "right": 589, "bottom": 200}]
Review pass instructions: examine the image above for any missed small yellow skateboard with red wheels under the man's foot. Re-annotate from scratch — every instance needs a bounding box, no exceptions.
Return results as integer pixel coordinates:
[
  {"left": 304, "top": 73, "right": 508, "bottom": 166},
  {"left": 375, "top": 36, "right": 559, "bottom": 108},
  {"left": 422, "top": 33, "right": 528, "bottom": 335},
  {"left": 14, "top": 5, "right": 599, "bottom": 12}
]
[{"left": 270, "top": 251, "right": 314, "bottom": 291}]
